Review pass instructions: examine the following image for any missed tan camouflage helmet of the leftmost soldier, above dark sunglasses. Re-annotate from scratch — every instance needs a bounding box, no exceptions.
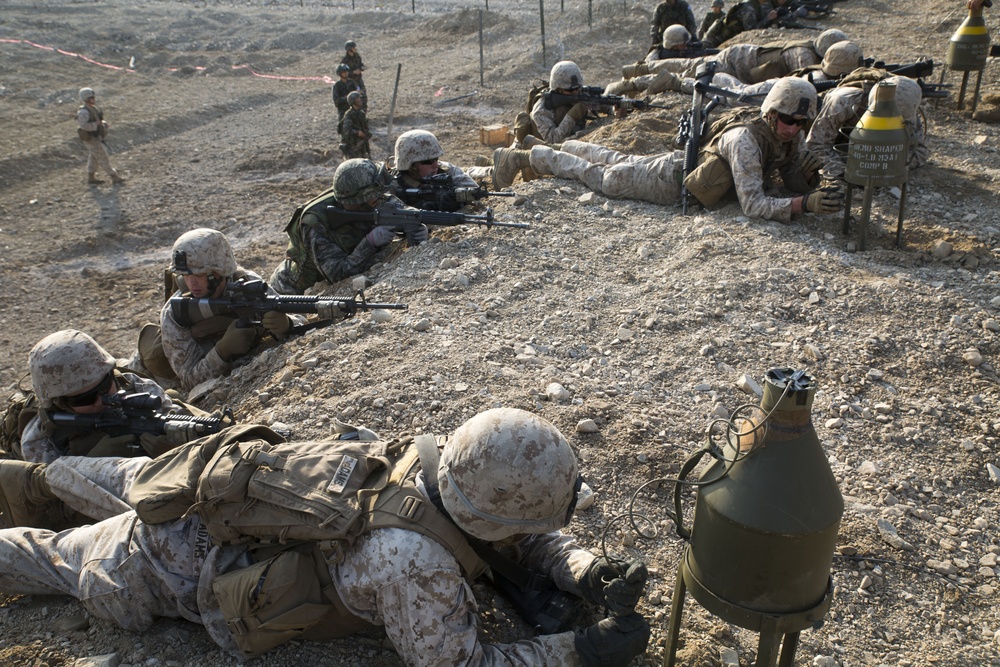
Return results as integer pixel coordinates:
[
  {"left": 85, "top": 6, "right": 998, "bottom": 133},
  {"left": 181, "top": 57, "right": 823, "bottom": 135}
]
[{"left": 28, "top": 329, "right": 115, "bottom": 408}]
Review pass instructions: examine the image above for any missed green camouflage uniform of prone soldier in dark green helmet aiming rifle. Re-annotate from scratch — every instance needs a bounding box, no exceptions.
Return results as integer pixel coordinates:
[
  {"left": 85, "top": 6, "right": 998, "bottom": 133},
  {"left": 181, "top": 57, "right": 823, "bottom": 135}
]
[{"left": 269, "top": 190, "right": 404, "bottom": 294}]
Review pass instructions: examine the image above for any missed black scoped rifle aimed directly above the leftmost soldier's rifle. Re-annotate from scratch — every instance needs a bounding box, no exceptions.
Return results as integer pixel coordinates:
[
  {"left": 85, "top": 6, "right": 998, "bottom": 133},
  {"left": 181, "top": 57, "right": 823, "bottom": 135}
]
[{"left": 170, "top": 278, "right": 409, "bottom": 334}]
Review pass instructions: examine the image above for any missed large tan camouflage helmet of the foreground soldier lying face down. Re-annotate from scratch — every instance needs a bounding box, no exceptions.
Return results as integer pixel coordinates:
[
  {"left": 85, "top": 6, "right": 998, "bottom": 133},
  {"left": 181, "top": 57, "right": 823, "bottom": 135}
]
[{"left": 438, "top": 408, "right": 578, "bottom": 542}]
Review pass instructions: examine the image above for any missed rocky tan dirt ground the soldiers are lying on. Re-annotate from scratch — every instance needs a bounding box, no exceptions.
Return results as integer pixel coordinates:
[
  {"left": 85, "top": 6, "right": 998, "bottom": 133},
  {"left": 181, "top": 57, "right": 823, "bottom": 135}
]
[{"left": 0, "top": 0, "right": 1000, "bottom": 667}]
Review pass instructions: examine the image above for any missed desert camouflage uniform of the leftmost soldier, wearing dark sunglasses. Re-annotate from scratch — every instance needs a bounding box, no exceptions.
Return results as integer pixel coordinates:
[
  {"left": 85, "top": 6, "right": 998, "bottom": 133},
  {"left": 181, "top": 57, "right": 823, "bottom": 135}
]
[{"left": 21, "top": 373, "right": 177, "bottom": 463}]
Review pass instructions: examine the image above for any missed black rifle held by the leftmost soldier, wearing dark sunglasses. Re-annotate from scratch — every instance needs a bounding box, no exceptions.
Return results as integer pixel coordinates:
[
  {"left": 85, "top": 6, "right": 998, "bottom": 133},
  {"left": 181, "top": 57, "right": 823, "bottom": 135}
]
[{"left": 48, "top": 391, "right": 236, "bottom": 444}]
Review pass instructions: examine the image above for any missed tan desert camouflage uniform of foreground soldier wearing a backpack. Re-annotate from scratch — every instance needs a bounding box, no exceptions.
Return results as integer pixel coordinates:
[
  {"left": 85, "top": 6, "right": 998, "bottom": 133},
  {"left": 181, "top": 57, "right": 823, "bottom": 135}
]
[{"left": 0, "top": 459, "right": 594, "bottom": 667}]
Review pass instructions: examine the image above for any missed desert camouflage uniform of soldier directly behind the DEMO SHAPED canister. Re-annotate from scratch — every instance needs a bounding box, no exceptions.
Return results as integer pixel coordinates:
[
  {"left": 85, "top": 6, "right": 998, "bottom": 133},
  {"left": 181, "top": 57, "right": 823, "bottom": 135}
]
[{"left": 806, "top": 86, "right": 930, "bottom": 178}]
